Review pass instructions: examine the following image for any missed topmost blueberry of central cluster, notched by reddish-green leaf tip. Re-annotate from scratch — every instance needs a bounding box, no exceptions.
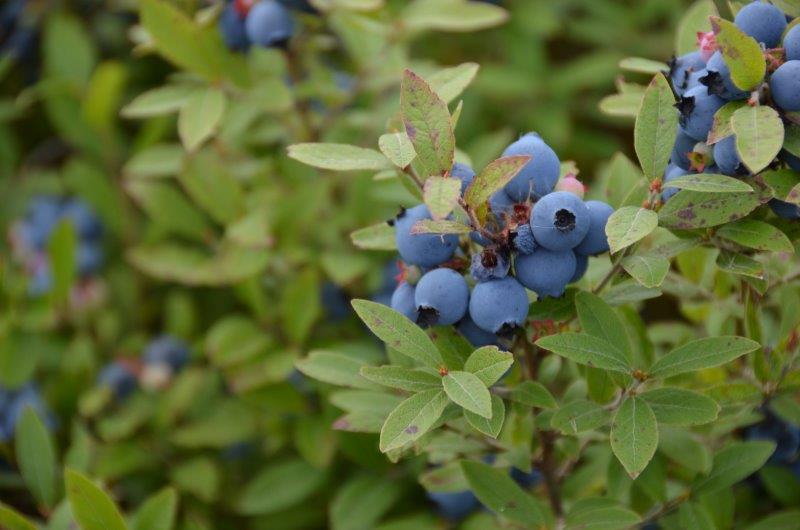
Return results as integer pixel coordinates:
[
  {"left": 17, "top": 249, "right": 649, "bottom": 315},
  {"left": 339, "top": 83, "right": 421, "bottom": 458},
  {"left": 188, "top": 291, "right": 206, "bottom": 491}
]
[{"left": 503, "top": 133, "right": 561, "bottom": 202}]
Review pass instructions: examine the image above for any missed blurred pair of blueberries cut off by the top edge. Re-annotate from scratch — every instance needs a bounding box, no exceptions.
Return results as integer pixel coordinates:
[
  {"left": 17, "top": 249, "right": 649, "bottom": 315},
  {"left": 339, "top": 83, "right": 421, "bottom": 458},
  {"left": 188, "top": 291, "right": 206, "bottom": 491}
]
[{"left": 219, "top": 0, "right": 296, "bottom": 51}]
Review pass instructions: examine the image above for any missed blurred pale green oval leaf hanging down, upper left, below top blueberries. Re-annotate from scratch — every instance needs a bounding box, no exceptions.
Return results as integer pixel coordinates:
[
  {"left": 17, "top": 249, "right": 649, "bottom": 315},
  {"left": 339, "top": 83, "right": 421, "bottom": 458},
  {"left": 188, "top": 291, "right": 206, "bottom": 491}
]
[{"left": 178, "top": 88, "right": 227, "bottom": 151}]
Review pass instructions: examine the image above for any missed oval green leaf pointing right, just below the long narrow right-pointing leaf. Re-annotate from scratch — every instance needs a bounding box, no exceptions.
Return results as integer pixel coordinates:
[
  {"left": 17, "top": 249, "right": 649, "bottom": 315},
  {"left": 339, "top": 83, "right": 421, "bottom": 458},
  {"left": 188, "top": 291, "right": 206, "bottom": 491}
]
[{"left": 639, "top": 387, "right": 720, "bottom": 426}]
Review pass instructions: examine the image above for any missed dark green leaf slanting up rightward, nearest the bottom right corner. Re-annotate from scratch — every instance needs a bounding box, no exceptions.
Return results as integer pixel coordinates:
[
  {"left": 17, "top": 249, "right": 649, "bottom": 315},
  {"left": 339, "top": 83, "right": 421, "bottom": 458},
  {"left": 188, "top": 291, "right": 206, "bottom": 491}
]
[{"left": 692, "top": 441, "right": 775, "bottom": 495}]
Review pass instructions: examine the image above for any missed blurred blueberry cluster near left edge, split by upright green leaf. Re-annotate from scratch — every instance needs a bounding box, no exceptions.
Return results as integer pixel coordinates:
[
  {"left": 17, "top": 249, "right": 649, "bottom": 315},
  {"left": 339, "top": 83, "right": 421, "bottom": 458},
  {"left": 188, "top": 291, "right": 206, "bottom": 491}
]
[{"left": 11, "top": 195, "right": 103, "bottom": 295}]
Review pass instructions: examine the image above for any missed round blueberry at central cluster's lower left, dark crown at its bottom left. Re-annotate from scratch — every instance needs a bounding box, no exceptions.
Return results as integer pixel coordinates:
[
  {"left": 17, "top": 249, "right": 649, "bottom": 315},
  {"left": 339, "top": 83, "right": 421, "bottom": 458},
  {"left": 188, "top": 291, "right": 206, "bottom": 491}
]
[{"left": 414, "top": 268, "right": 469, "bottom": 326}]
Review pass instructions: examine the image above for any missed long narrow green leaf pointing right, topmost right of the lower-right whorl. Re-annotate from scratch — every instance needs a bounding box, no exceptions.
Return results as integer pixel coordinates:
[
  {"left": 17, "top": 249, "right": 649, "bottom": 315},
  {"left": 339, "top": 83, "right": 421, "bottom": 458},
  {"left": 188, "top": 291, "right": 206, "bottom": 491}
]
[{"left": 650, "top": 336, "right": 761, "bottom": 379}]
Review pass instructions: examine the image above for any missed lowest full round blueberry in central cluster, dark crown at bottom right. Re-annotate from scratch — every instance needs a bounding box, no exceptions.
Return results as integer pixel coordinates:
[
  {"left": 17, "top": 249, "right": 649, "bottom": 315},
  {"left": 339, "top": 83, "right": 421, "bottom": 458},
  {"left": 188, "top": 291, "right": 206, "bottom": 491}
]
[{"left": 469, "top": 274, "right": 529, "bottom": 335}]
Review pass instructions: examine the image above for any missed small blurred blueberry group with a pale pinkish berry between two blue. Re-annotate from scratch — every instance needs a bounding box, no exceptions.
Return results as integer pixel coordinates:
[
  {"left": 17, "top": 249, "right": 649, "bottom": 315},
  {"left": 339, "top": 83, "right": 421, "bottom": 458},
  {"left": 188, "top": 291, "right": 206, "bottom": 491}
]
[{"left": 97, "top": 335, "right": 190, "bottom": 400}]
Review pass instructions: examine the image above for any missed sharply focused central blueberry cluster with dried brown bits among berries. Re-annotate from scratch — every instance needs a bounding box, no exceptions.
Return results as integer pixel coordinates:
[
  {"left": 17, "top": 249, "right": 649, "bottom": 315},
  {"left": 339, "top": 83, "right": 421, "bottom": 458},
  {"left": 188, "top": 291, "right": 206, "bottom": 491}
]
[{"left": 391, "top": 133, "right": 613, "bottom": 346}]
